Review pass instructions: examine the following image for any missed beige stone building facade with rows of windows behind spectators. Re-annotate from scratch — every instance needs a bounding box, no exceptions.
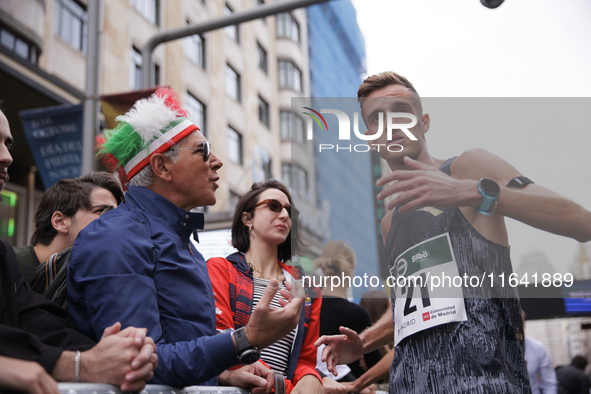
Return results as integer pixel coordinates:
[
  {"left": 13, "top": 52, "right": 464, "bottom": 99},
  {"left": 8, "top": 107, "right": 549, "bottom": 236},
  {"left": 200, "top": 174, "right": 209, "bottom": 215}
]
[{"left": 0, "top": 0, "right": 318, "bottom": 253}]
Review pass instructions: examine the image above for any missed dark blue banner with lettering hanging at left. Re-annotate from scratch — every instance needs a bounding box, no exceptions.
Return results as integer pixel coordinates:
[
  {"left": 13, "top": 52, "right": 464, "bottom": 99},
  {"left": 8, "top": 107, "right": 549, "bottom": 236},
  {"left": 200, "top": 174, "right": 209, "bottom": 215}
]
[{"left": 19, "top": 104, "right": 82, "bottom": 189}]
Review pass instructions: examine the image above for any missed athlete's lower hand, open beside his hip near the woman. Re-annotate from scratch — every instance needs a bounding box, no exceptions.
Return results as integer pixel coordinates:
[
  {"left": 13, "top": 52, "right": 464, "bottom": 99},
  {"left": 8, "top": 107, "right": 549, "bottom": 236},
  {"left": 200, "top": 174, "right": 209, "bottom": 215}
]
[{"left": 314, "top": 327, "right": 363, "bottom": 376}]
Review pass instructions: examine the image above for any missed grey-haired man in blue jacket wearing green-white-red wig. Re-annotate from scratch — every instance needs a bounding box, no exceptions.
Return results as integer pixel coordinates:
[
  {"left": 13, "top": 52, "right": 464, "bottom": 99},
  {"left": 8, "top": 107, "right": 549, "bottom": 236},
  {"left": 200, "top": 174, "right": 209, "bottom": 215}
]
[{"left": 68, "top": 89, "right": 303, "bottom": 392}]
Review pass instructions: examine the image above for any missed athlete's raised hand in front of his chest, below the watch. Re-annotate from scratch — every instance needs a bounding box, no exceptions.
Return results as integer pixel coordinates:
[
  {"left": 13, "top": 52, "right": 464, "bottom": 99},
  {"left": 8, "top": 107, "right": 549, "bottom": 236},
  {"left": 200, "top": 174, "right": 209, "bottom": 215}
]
[{"left": 376, "top": 156, "right": 482, "bottom": 213}]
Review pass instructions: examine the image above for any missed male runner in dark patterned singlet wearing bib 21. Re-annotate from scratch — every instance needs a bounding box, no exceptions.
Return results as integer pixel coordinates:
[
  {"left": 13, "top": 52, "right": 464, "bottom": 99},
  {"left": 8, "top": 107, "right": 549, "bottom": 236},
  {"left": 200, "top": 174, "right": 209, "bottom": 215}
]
[{"left": 316, "top": 72, "right": 591, "bottom": 393}]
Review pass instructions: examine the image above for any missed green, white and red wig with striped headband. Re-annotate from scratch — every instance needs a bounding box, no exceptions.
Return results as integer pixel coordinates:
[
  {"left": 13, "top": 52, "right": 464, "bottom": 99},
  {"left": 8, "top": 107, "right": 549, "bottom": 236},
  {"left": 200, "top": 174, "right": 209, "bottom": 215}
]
[{"left": 97, "top": 88, "right": 199, "bottom": 184}]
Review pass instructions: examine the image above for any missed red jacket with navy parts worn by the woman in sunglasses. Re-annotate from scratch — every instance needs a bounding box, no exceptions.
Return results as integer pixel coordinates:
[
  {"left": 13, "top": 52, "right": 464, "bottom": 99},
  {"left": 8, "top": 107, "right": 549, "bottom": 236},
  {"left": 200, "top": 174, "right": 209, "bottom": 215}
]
[{"left": 207, "top": 253, "right": 322, "bottom": 393}]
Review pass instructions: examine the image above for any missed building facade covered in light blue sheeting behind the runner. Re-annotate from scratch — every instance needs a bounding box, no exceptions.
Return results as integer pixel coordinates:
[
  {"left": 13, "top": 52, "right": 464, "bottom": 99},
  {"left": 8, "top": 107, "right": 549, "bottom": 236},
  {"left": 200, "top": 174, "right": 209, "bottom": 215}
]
[{"left": 308, "top": 0, "right": 381, "bottom": 298}]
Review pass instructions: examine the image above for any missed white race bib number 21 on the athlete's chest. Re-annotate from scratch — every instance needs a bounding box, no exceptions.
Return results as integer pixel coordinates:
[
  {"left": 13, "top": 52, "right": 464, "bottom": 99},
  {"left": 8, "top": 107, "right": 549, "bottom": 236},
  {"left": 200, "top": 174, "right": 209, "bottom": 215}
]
[{"left": 390, "top": 233, "right": 467, "bottom": 345}]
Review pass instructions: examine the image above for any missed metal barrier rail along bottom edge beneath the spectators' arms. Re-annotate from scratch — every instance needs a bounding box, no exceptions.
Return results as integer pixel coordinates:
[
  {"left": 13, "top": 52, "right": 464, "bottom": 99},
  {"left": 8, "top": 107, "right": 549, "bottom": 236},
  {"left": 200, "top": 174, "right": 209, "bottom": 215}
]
[{"left": 58, "top": 383, "right": 248, "bottom": 394}]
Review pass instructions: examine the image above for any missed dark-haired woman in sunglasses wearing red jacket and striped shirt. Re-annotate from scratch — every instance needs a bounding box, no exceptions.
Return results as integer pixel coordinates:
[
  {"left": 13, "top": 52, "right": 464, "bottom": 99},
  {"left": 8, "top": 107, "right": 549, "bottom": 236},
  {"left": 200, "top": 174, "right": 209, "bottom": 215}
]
[{"left": 207, "top": 180, "right": 323, "bottom": 394}]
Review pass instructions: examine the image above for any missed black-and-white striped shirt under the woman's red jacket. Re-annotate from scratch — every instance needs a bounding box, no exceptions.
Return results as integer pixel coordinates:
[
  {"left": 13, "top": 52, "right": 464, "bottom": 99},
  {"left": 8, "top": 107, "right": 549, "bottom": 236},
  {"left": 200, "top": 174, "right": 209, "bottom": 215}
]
[{"left": 252, "top": 278, "right": 297, "bottom": 376}]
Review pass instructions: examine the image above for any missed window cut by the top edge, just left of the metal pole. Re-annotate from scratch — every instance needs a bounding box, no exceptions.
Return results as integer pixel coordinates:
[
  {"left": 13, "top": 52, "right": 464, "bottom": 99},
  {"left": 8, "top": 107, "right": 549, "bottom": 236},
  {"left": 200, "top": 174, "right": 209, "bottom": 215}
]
[{"left": 55, "top": 0, "right": 88, "bottom": 52}]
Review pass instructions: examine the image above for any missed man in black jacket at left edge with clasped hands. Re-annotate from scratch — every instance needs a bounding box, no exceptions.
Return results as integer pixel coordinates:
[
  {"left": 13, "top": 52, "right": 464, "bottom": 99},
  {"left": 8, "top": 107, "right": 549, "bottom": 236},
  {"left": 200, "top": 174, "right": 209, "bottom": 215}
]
[{"left": 0, "top": 107, "right": 157, "bottom": 393}]
